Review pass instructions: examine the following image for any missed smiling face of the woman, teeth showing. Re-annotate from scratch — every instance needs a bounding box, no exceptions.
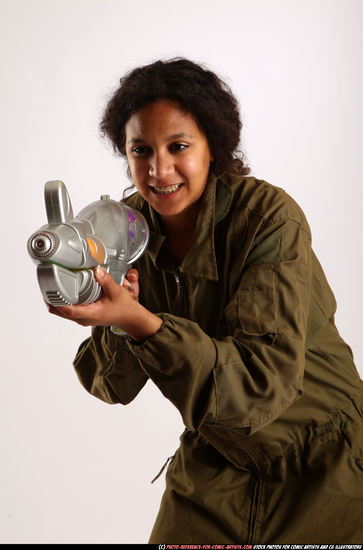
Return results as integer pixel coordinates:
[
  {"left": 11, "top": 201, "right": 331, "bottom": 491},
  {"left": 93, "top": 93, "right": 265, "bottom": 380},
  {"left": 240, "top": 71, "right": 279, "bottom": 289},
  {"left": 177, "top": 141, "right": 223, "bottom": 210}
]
[{"left": 125, "top": 100, "right": 213, "bottom": 225}]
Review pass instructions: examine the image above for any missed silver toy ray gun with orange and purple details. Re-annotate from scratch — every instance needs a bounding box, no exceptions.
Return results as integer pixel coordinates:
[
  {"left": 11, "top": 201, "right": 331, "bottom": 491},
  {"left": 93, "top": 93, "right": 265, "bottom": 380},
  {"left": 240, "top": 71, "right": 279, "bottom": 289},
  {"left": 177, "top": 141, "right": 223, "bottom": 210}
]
[{"left": 28, "top": 181, "right": 149, "bottom": 306}]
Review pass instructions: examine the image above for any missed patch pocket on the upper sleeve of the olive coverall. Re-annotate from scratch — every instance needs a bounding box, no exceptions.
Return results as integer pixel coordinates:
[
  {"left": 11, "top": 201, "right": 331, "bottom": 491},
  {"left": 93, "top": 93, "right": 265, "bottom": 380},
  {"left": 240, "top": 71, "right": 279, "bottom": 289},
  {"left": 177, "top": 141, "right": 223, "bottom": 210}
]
[{"left": 225, "top": 264, "right": 277, "bottom": 336}]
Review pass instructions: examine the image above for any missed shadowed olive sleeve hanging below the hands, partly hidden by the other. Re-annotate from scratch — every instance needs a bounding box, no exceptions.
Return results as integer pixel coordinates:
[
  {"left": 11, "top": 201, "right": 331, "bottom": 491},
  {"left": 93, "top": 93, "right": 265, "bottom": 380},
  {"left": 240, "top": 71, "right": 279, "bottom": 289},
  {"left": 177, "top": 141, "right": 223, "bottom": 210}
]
[{"left": 73, "top": 327, "right": 148, "bottom": 405}]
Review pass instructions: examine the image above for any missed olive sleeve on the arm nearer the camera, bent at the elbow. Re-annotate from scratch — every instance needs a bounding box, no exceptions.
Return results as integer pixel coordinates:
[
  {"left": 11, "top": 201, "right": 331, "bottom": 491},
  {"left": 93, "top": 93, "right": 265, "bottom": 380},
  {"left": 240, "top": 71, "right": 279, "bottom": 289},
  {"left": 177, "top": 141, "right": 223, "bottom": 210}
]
[{"left": 120, "top": 216, "right": 311, "bottom": 435}]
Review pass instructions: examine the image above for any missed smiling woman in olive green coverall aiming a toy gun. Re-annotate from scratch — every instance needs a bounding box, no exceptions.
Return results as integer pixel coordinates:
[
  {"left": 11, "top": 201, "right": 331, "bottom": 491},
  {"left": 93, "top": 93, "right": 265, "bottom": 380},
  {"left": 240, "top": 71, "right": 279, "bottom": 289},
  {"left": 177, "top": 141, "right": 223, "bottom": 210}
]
[{"left": 50, "top": 59, "right": 363, "bottom": 544}]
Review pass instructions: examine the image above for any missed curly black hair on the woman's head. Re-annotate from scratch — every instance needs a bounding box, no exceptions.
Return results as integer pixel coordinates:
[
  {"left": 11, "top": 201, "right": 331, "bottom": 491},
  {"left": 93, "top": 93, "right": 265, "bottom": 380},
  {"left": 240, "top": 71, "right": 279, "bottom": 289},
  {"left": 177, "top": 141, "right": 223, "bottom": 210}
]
[{"left": 100, "top": 57, "right": 250, "bottom": 176}]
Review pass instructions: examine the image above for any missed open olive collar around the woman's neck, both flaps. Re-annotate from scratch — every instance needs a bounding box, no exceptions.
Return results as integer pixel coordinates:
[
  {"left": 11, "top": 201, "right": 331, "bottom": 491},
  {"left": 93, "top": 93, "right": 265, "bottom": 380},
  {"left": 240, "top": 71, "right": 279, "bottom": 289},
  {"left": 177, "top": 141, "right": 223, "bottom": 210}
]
[{"left": 136, "top": 175, "right": 233, "bottom": 281}]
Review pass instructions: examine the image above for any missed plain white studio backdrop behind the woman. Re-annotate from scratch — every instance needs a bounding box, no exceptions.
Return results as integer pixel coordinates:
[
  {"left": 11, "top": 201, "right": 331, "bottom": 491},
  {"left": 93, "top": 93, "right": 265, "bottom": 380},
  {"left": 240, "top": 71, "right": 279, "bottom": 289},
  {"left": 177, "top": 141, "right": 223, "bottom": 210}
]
[{"left": 0, "top": 0, "right": 363, "bottom": 543}]
